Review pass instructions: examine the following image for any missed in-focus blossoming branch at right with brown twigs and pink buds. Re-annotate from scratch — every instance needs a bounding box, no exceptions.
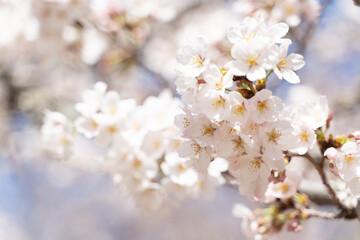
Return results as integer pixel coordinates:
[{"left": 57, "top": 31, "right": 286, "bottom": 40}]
[{"left": 172, "top": 15, "right": 360, "bottom": 239}]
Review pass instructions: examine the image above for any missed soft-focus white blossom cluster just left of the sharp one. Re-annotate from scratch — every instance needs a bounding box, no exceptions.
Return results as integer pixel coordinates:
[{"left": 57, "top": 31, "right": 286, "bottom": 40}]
[{"left": 42, "top": 82, "right": 224, "bottom": 211}]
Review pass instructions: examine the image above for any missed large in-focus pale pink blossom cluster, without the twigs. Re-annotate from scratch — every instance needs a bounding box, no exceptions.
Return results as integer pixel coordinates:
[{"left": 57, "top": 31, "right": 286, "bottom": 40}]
[{"left": 175, "top": 18, "right": 329, "bottom": 201}]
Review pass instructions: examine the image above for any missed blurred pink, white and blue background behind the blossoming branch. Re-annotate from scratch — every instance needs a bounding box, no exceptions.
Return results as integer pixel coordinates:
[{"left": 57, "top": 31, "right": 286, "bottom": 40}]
[{"left": 0, "top": 0, "right": 360, "bottom": 240}]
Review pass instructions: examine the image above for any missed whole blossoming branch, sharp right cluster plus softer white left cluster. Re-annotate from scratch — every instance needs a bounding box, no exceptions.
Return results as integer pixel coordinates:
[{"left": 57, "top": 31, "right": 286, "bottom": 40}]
[{"left": 42, "top": 8, "right": 360, "bottom": 238}]
